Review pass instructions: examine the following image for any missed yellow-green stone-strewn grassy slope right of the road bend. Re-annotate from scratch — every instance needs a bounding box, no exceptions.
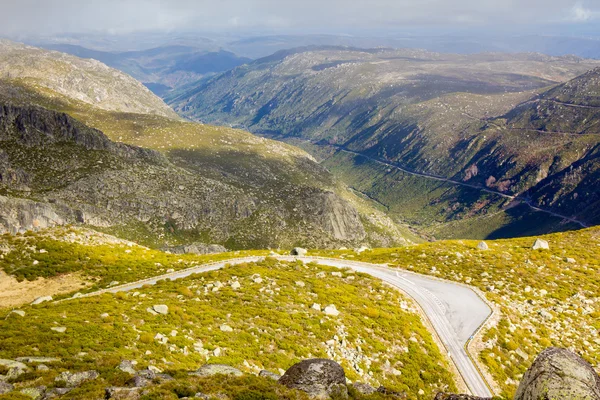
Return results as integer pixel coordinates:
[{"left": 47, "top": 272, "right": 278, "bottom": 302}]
[{"left": 317, "top": 228, "right": 600, "bottom": 398}]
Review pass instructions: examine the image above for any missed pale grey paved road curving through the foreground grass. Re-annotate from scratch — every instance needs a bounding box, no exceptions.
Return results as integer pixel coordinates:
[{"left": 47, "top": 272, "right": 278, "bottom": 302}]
[{"left": 68, "top": 256, "right": 492, "bottom": 397}]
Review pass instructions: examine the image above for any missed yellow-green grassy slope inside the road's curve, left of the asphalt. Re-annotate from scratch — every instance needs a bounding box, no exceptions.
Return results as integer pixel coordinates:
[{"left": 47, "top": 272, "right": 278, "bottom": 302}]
[{"left": 0, "top": 250, "right": 455, "bottom": 398}]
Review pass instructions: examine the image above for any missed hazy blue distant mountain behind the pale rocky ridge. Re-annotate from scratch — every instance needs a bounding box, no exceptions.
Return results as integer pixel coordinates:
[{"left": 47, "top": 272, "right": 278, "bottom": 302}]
[{"left": 43, "top": 44, "right": 251, "bottom": 95}]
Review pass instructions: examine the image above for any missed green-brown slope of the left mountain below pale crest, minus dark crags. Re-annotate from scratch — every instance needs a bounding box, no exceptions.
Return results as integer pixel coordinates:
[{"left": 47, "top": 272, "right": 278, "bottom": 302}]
[{"left": 0, "top": 44, "right": 412, "bottom": 248}]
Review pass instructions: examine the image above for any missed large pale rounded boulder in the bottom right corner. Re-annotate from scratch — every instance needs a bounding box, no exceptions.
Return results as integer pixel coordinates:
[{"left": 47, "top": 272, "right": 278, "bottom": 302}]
[{"left": 515, "top": 347, "right": 600, "bottom": 400}]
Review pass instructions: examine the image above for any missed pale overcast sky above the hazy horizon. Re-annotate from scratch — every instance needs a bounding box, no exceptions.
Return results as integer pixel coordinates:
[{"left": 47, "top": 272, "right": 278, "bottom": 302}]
[{"left": 0, "top": 0, "right": 600, "bottom": 36}]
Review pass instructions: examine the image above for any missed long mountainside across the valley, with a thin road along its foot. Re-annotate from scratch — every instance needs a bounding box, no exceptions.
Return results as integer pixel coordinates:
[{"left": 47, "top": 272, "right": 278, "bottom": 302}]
[{"left": 167, "top": 47, "right": 598, "bottom": 238}]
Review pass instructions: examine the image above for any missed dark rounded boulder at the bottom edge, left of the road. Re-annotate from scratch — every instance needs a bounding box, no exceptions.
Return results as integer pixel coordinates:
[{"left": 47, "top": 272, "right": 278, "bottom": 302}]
[{"left": 279, "top": 358, "right": 347, "bottom": 399}]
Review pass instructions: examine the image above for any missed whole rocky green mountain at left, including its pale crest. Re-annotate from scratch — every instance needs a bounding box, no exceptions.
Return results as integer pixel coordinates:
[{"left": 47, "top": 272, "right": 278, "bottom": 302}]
[{"left": 0, "top": 40, "right": 404, "bottom": 249}]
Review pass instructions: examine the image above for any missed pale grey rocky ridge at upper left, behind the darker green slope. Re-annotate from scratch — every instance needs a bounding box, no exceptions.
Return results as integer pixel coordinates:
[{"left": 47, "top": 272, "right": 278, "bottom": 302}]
[{"left": 0, "top": 39, "right": 177, "bottom": 118}]
